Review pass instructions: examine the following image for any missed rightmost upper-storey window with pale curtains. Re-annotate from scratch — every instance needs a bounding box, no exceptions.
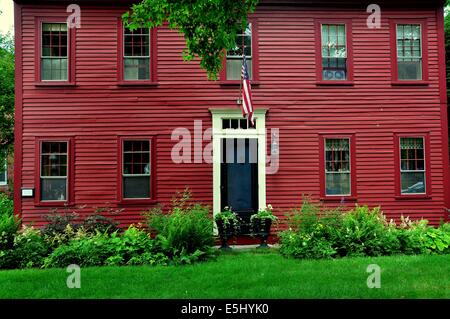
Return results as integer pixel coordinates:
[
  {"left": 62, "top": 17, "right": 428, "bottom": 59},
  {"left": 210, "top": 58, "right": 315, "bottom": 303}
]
[{"left": 396, "top": 24, "right": 422, "bottom": 80}]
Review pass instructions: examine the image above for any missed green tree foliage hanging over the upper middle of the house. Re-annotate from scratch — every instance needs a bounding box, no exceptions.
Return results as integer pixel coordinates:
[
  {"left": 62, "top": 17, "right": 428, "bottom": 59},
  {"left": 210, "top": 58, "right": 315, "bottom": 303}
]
[{"left": 123, "top": 0, "right": 258, "bottom": 79}]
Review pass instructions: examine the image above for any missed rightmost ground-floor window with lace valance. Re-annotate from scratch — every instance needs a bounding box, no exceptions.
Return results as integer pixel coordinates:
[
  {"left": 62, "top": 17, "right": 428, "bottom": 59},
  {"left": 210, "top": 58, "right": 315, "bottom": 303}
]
[{"left": 400, "top": 137, "right": 426, "bottom": 194}]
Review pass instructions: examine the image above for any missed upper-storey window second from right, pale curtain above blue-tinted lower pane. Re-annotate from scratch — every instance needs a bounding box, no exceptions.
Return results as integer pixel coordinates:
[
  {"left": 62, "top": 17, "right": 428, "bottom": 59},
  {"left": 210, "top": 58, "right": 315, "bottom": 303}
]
[{"left": 321, "top": 24, "right": 347, "bottom": 81}]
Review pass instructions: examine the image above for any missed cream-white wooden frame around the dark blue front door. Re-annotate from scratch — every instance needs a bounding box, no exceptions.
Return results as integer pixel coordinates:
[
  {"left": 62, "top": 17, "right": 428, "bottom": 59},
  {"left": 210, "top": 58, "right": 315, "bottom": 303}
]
[{"left": 209, "top": 108, "right": 267, "bottom": 222}]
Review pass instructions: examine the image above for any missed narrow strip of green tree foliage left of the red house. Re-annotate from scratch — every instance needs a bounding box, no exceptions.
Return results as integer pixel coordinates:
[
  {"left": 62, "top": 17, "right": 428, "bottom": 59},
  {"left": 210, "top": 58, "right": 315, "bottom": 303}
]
[{"left": 0, "top": 33, "right": 14, "bottom": 160}]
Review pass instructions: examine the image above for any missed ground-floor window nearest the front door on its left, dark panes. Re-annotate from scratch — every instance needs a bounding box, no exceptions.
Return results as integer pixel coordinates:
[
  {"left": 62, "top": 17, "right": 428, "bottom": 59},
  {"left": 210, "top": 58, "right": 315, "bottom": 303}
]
[{"left": 122, "top": 140, "right": 151, "bottom": 199}]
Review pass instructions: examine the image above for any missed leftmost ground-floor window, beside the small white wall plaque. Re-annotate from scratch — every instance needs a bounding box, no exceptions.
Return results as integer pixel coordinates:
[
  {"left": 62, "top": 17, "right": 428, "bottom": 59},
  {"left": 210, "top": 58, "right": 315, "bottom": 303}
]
[{"left": 40, "top": 142, "right": 68, "bottom": 201}]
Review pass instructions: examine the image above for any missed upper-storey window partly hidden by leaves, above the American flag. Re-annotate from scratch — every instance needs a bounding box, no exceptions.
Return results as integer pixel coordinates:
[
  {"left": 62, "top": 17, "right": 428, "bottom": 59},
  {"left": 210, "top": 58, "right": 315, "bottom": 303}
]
[{"left": 226, "top": 23, "right": 253, "bottom": 80}]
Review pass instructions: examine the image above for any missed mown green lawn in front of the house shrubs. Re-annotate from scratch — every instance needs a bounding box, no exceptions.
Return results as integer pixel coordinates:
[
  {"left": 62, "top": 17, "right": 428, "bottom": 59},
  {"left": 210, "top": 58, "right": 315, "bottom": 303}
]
[{"left": 0, "top": 252, "right": 450, "bottom": 298}]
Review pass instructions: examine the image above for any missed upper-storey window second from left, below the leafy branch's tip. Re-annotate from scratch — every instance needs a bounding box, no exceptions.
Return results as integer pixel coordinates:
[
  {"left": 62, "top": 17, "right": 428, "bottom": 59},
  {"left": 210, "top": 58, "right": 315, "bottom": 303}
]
[{"left": 123, "top": 28, "right": 150, "bottom": 81}]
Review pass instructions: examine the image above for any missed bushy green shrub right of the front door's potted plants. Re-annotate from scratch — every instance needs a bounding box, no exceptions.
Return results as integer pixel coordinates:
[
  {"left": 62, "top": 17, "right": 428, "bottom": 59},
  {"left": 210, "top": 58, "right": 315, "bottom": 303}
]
[{"left": 280, "top": 200, "right": 402, "bottom": 258}]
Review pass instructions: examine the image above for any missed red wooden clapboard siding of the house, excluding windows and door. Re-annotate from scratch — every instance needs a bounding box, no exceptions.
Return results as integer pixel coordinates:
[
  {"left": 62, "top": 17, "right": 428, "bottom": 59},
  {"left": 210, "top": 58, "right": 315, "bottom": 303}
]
[{"left": 15, "top": 4, "right": 449, "bottom": 225}]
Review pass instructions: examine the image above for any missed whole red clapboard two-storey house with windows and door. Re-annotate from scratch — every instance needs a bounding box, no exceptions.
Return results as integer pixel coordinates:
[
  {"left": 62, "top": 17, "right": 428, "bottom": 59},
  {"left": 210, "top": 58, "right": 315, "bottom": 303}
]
[{"left": 14, "top": 0, "right": 450, "bottom": 230}]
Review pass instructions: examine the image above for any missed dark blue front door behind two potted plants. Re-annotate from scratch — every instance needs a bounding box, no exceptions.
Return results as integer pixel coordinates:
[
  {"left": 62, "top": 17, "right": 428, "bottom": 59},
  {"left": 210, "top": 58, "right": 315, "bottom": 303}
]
[{"left": 221, "top": 138, "right": 258, "bottom": 231}]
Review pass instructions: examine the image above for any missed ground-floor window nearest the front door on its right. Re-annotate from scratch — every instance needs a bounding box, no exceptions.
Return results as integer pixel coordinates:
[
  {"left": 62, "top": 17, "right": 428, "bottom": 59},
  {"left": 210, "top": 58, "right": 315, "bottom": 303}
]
[{"left": 325, "top": 138, "right": 351, "bottom": 196}]
